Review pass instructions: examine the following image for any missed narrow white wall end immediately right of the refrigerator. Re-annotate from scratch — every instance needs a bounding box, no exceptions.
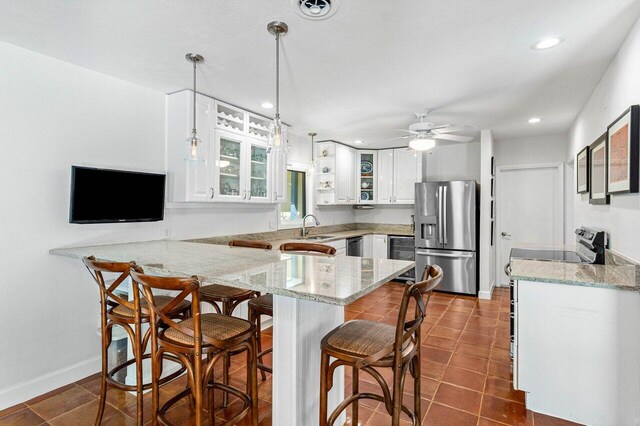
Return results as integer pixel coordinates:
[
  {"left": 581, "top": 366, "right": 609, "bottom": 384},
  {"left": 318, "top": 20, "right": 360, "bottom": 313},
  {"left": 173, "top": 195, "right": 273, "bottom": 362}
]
[{"left": 478, "top": 130, "right": 496, "bottom": 299}]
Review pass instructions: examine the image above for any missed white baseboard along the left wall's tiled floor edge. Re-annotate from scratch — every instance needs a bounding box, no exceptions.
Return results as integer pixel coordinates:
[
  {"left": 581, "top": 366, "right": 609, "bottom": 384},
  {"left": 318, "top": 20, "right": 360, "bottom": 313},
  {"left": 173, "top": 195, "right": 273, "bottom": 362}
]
[{"left": 0, "top": 357, "right": 102, "bottom": 410}]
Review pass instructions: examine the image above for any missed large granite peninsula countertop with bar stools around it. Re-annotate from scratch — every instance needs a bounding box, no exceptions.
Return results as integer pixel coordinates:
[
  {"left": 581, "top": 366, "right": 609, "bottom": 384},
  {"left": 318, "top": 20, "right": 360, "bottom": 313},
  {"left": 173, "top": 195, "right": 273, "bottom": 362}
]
[{"left": 50, "top": 240, "right": 415, "bottom": 306}]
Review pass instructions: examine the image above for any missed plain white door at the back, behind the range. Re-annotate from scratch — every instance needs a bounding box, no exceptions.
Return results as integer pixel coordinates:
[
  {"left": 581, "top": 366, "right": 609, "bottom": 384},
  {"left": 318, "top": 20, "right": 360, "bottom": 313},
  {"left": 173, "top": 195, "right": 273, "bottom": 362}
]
[{"left": 495, "top": 164, "right": 564, "bottom": 286}]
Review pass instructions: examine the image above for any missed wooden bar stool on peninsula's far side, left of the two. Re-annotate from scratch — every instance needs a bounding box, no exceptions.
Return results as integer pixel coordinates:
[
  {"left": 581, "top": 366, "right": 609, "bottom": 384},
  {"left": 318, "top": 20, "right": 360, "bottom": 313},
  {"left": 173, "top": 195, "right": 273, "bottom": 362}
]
[{"left": 200, "top": 240, "right": 273, "bottom": 407}]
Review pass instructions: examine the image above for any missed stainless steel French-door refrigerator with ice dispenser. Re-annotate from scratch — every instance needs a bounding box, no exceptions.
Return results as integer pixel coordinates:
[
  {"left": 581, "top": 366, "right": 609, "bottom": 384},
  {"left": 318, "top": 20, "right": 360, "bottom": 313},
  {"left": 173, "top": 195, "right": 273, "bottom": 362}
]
[{"left": 415, "top": 180, "right": 480, "bottom": 295}]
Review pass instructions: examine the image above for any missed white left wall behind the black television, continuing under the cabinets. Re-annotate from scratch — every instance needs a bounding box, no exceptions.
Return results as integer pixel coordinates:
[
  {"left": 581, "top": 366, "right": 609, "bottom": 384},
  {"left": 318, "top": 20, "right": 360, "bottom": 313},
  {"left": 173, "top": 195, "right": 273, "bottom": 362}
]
[{"left": 0, "top": 43, "right": 354, "bottom": 410}]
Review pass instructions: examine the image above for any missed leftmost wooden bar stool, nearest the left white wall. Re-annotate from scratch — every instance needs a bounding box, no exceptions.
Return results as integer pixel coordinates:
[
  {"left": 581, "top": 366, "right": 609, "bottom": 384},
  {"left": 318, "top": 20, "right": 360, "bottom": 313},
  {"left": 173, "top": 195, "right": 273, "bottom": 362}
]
[{"left": 82, "top": 256, "right": 191, "bottom": 425}]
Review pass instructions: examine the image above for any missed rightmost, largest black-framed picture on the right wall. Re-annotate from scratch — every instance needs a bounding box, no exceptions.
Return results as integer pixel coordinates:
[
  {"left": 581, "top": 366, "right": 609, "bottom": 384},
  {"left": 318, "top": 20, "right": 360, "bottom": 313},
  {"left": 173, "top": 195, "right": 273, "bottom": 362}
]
[{"left": 607, "top": 105, "right": 640, "bottom": 194}]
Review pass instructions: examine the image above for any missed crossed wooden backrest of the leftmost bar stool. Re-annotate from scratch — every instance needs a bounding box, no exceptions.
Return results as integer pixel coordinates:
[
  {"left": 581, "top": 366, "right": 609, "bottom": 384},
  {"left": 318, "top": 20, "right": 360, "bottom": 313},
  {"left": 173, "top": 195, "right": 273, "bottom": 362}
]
[{"left": 82, "top": 256, "right": 140, "bottom": 313}]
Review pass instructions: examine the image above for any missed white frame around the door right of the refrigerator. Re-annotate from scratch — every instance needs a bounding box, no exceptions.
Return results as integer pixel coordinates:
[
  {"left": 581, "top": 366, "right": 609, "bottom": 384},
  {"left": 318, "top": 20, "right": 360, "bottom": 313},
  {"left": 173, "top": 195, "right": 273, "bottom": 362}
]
[{"left": 494, "top": 162, "right": 565, "bottom": 287}]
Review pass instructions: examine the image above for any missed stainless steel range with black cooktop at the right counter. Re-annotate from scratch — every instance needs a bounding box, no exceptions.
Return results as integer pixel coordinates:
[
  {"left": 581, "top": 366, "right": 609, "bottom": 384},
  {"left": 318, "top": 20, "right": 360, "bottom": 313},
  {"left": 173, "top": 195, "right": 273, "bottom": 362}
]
[{"left": 504, "top": 226, "right": 607, "bottom": 358}]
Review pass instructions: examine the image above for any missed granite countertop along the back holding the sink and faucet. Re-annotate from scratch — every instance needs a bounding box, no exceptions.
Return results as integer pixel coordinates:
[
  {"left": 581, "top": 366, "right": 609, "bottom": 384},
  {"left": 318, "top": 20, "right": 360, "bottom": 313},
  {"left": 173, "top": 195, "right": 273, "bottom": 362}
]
[{"left": 189, "top": 224, "right": 413, "bottom": 249}]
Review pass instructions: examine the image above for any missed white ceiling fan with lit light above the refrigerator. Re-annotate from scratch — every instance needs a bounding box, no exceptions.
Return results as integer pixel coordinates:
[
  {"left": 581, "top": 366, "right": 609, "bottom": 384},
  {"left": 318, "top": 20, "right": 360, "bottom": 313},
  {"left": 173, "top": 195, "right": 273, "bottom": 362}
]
[{"left": 396, "top": 110, "right": 477, "bottom": 151}]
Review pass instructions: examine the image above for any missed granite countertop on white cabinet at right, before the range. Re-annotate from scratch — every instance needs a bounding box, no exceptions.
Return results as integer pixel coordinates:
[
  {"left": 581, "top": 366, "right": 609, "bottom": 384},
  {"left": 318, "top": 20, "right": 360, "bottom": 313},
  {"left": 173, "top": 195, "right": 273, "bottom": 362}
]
[{"left": 511, "top": 259, "right": 640, "bottom": 291}]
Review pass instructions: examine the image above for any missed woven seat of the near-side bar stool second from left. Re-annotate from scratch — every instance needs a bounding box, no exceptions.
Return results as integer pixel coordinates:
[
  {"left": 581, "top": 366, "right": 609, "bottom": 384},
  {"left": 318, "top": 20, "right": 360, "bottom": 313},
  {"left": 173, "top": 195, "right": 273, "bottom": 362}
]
[{"left": 164, "top": 314, "right": 253, "bottom": 346}]
